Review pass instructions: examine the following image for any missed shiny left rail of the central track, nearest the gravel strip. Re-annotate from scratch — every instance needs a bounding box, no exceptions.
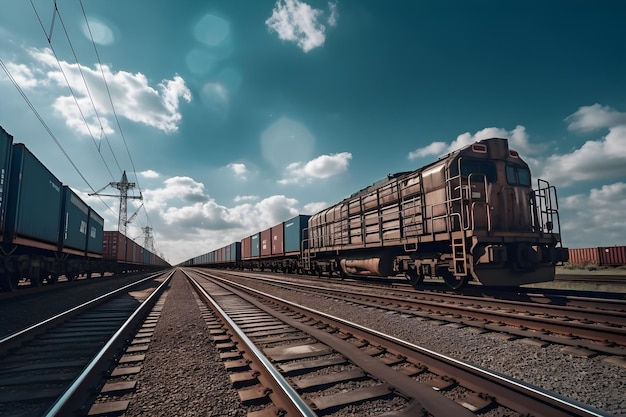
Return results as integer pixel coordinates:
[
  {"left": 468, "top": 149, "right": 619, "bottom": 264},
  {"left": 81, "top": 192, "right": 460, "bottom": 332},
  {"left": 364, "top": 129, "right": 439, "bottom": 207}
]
[{"left": 182, "top": 269, "right": 317, "bottom": 417}]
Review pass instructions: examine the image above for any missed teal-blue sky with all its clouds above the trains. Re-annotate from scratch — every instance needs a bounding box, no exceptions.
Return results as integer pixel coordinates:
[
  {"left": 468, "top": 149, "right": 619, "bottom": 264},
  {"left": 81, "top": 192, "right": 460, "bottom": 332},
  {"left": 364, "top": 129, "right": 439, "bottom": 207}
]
[{"left": 0, "top": 0, "right": 626, "bottom": 263}]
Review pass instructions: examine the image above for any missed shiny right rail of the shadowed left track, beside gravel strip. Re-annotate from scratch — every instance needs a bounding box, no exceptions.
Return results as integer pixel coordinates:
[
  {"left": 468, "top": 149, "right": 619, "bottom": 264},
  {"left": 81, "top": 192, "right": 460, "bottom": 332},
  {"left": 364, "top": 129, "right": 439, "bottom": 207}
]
[{"left": 43, "top": 270, "right": 175, "bottom": 417}]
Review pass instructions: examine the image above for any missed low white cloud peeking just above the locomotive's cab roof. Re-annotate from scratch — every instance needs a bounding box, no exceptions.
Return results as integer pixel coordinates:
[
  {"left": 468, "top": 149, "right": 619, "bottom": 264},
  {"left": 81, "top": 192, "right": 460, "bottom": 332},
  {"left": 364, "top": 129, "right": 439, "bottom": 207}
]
[{"left": 409, "top": 125, "right": 543, "bottom": 159}]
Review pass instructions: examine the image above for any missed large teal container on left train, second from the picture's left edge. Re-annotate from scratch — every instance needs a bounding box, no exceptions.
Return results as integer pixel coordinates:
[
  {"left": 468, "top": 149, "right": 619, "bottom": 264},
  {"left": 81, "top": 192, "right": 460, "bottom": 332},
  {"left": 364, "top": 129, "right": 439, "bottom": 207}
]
[{"left": 5, "top": 143, "right": 62, "bottom": 250}]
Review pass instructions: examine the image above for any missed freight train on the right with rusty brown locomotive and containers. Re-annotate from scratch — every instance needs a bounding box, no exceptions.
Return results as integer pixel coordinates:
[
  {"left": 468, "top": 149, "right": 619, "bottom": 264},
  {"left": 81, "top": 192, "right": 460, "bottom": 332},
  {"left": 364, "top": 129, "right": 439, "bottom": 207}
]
[{"left": 183, "top": 138, "right": 568, "bottom": 289}]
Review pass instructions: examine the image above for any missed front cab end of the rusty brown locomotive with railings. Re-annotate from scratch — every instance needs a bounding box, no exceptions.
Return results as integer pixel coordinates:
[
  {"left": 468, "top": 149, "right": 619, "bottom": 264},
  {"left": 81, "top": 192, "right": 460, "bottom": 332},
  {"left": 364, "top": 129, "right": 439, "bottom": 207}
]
[{"left": 444, "top": 138, "right": 567, "bottom": 286}]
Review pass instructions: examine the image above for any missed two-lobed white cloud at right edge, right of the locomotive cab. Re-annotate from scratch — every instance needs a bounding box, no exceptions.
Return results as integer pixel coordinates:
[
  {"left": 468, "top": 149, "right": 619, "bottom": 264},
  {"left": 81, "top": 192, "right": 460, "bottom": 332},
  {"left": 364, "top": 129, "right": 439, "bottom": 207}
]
[{"left": 541, "top": 104, "right": 626, "bottom": 185}]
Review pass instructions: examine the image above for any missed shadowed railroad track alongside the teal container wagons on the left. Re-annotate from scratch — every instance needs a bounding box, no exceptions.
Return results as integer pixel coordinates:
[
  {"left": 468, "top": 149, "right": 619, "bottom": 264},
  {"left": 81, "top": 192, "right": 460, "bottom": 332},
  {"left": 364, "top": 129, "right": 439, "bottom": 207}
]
[{"left": 0, "top": 272, "right": 173, "bottom": 416}]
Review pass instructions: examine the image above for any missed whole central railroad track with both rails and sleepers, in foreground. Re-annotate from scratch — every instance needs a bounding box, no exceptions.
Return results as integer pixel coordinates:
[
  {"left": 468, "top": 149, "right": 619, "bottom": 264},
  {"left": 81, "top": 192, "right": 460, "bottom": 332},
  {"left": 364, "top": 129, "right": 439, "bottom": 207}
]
[{"left": 186, "top": 271, "right": 603, "bottom": 417}]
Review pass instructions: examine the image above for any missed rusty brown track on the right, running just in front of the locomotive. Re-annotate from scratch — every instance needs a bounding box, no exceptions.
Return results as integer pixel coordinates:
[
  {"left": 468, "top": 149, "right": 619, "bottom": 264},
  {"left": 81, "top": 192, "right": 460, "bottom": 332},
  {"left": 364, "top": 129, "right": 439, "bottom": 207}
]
[{"left": 208, "top": 273, "right": 626, "bottom": 357}]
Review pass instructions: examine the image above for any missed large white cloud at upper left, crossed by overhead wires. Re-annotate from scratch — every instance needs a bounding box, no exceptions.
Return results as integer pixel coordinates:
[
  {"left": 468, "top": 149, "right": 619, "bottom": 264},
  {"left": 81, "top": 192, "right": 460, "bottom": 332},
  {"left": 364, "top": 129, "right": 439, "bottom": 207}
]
[{"left": 19, "top": 49, "right": 191, "bottom": 138}]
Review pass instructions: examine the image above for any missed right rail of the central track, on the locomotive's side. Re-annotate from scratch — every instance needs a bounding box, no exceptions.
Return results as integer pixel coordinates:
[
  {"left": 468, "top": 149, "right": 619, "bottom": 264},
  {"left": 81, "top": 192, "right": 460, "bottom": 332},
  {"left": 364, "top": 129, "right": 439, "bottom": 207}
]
[{"left": 200, "top": 273, "right": 610, "bottom": 417}]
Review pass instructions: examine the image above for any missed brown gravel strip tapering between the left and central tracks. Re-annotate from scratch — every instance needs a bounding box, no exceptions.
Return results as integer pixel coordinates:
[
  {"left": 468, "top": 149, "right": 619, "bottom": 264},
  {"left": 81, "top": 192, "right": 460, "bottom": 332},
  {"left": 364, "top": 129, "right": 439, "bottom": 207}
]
[{"left": 125, "top": 272, "right": 246, "bottom": 417}]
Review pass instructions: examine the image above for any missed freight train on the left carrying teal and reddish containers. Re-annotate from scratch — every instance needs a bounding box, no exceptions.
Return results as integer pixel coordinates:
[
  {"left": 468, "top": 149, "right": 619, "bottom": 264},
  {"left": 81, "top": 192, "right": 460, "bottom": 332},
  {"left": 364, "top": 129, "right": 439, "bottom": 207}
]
[{"left": 0, "top": 126, "right": 168, "bottom": 291}]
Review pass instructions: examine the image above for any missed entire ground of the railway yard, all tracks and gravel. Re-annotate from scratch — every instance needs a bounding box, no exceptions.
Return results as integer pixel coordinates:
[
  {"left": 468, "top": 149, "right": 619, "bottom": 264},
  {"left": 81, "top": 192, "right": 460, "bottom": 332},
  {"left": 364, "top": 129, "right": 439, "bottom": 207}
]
[{"left": 0, "top": 268, "right": 626, "bottom": 417}]
